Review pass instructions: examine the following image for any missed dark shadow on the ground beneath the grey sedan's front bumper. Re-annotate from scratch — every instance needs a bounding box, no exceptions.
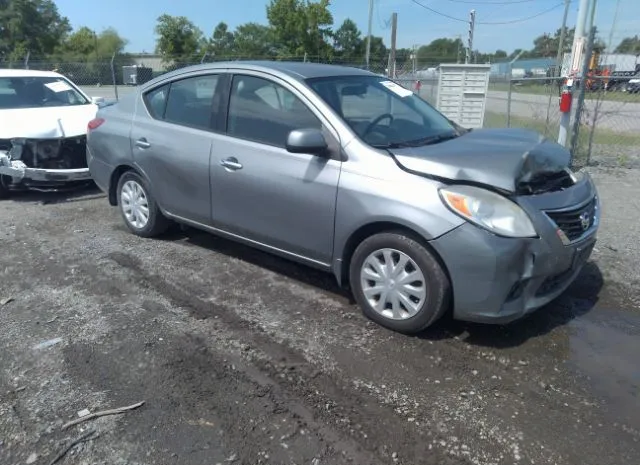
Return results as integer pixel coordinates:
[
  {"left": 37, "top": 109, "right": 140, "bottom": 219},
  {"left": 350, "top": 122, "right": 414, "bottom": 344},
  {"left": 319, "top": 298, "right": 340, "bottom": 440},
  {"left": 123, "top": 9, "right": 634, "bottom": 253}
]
[{"left": 418, "top": 262, "right": 604, "bottom": 349}]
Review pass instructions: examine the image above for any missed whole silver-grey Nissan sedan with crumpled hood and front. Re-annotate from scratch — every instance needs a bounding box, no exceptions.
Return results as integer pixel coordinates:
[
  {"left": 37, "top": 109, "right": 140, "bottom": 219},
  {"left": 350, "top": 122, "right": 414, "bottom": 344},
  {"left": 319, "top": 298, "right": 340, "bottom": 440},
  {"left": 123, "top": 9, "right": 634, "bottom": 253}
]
[{"left": 87, "top": 62, "right": 600, "bottom": 333}]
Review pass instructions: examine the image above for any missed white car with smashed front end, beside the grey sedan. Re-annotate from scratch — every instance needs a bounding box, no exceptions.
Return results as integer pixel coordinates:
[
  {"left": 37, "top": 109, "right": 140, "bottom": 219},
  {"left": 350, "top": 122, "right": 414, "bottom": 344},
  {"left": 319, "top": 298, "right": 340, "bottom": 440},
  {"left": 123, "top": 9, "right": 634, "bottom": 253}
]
[{"left": 0, "top": 69, "right": 104, "bottom": 198}]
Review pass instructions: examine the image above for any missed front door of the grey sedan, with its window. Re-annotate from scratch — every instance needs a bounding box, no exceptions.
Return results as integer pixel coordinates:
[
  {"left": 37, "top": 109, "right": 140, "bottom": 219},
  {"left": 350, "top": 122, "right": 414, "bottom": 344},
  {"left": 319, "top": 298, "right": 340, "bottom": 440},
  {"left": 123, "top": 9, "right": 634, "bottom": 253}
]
[{"left": 211, "top": 74, "right": 341, "bottom": 264}]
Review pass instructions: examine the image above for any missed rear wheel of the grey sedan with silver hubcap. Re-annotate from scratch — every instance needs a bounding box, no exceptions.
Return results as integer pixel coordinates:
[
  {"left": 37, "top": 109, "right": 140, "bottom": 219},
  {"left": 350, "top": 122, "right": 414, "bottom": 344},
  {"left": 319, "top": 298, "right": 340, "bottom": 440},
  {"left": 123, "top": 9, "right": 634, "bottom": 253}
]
[{"left": 116, "top": 171, "right": 170, "bottom": 237}]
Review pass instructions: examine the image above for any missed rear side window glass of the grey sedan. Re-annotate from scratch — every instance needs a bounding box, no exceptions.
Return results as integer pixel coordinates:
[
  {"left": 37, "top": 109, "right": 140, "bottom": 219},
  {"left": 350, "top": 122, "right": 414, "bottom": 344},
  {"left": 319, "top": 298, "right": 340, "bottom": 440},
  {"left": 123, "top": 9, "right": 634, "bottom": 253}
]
[{"left": 145, "top": 75, "right": 219, "bottom": 129}]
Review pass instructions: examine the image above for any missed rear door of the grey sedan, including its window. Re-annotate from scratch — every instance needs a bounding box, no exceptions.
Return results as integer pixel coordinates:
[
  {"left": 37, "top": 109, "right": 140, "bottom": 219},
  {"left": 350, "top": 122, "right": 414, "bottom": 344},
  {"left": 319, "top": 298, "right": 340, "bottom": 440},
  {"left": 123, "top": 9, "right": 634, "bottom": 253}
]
[{"left": 131, "top": 72, "right": 227, "bottom": 224}]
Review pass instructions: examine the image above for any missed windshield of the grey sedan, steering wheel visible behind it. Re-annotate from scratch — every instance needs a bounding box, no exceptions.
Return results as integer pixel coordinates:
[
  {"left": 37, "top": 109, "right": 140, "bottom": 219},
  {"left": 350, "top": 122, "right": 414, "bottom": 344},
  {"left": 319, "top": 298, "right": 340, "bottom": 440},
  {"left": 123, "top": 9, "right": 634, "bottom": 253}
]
[{"left": 307, "top": 76, "right": 458, "bottom": 148}]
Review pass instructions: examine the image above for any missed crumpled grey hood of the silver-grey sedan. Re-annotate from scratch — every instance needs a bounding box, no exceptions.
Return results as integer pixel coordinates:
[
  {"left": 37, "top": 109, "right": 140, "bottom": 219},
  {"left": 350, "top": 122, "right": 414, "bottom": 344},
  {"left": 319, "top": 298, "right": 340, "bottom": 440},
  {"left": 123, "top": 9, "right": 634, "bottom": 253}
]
[{"left": 391, "top": 129, "right": 570, "bottom": 193}]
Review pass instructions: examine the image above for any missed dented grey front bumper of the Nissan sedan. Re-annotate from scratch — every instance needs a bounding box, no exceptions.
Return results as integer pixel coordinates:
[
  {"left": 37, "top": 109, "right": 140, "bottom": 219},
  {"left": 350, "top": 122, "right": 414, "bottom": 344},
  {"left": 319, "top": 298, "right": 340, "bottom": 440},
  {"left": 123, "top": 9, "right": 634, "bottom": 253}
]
[{"left": 431, "top": 185, "right": 600, "bottom": 324}]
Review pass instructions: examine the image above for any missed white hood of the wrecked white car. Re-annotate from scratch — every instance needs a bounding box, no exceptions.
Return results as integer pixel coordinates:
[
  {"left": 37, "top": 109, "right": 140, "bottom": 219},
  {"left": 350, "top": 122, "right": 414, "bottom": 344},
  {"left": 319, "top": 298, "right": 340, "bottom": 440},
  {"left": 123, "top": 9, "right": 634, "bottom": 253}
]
[{"left": 0, "top": 104, "right": 98, "bottom": 139}]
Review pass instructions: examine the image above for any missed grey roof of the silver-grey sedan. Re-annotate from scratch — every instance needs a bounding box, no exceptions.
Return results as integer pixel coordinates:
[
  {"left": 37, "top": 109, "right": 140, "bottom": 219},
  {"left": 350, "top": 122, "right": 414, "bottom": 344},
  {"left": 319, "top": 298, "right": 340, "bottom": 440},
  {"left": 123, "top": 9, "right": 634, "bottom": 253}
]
[{"left": 143, "top": 60, "right": 378, "bottom": 88}]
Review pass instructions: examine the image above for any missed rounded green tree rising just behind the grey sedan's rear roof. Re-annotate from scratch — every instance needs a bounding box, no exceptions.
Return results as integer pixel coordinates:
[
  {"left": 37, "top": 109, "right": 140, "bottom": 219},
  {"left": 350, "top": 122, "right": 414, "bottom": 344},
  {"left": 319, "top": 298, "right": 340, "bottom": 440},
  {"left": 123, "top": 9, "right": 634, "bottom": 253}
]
[{"left": 155, "top": 14, "right": 204, "bottom": 63}]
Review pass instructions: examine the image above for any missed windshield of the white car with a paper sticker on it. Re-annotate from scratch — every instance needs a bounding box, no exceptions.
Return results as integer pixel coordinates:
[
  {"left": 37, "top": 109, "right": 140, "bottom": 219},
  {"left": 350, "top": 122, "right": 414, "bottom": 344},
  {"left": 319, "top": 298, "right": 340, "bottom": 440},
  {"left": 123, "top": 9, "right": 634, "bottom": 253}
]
[{"left": 0, "top": 76, "right": 90, "bottom": 110}]
